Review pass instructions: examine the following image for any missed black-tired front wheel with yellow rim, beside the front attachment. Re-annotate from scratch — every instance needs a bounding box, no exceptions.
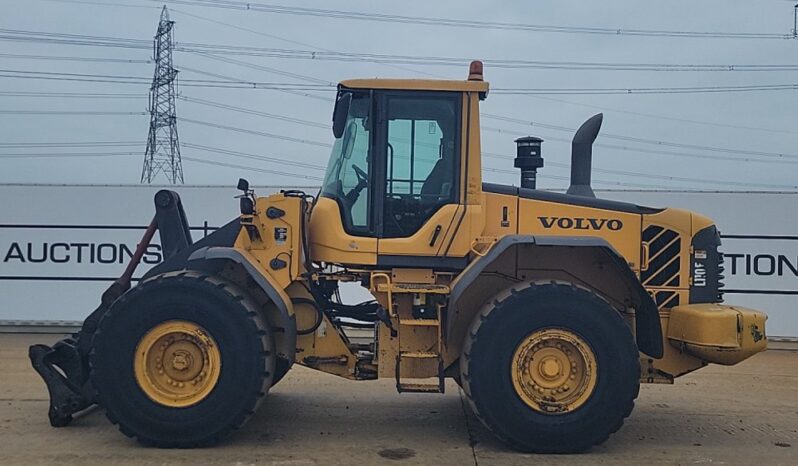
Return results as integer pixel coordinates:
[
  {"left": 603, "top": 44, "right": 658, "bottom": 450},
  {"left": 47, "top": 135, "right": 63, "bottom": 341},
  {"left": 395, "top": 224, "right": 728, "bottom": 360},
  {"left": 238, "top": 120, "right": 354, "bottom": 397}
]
[{"left": 90, "top": 271, "right": 275, "bottom": 447}]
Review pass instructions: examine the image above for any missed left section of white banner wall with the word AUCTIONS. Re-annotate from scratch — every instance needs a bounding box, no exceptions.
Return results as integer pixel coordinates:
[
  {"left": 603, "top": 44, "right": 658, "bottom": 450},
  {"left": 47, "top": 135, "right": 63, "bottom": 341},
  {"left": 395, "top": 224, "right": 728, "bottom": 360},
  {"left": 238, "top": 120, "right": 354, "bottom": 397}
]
[{"left": 0, "top": 185, "right": 294, "bottom": 320}]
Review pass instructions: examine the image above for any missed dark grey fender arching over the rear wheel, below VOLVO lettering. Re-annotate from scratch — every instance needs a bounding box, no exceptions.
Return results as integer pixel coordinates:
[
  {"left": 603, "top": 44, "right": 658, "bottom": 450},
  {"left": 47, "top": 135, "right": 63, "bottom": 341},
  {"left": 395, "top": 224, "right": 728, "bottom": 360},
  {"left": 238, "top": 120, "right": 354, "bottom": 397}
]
[{"left": 446, "top": 235, "right": 663, "bottom": 359}]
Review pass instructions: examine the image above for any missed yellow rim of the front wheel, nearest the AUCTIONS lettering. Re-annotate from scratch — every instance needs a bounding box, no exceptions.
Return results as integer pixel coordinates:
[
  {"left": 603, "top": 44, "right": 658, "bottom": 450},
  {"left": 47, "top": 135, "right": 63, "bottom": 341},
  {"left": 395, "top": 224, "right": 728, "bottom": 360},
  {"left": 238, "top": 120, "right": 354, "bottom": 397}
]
[{"left": 133, "top": 320, "right": 222, "bottom": 408}]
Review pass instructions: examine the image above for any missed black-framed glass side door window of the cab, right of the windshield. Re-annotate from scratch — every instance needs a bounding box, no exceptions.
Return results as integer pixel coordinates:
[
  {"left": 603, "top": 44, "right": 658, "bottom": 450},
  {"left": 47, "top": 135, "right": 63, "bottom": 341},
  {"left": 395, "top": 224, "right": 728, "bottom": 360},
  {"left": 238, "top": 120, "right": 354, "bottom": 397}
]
[{"left": 382, "top": 94, "right": 460, "bottom": 238}]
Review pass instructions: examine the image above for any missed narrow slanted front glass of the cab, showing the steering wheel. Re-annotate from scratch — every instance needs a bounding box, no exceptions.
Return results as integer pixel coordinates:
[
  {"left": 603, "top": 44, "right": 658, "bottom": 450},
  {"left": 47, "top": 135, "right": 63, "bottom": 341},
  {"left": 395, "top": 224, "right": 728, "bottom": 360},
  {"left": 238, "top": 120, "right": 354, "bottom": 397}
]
[{"left": 321, "top": 93, "right": 371, "bottom": 231}]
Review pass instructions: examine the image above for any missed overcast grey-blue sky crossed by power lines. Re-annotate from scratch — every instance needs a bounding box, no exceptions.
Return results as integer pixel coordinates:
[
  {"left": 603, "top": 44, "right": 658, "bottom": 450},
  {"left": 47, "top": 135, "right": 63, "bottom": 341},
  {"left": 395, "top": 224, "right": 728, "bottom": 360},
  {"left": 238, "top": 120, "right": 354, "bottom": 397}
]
[{"left": 0, "top": 0, "right": 798, "bottom": 190}]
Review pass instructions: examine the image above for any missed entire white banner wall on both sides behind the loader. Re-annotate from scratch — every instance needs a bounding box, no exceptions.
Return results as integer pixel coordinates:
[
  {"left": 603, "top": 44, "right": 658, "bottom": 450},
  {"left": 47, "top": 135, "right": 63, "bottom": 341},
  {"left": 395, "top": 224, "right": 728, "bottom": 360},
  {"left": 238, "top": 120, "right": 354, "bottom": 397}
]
[{"left": 0, "top": 185, "right": 798, "bottom": 337}]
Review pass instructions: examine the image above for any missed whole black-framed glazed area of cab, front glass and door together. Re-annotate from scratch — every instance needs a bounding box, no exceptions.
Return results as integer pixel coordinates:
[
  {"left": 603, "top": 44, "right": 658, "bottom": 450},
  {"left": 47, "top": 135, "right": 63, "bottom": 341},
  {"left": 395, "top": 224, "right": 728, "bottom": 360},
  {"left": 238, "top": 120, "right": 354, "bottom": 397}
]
[{"left": 321, "top": 88, "right": 461, "bottom": 238}]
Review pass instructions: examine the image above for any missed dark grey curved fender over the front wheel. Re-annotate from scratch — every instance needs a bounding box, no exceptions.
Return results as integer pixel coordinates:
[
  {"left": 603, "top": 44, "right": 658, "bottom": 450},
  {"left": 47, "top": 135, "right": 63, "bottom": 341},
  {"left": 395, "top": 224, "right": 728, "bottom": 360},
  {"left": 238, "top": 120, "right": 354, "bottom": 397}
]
[{"left": 188, "top": 247, "right": 296, "bottom": 364}]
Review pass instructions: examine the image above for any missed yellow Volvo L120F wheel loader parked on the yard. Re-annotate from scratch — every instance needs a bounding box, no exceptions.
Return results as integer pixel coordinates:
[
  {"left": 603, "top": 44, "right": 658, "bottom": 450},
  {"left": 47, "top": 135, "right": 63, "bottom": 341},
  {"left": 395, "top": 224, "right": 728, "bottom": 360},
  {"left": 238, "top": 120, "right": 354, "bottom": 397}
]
[{"left": 30, "top": 62, "right": 767, "bottom": 452}]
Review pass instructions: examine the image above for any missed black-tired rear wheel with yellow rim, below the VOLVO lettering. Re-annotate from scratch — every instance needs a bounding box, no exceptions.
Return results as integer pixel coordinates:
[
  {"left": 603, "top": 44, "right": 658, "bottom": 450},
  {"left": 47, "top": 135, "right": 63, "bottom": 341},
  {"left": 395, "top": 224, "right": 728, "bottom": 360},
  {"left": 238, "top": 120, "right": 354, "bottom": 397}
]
[{"left": 460, "top": 282, "right": 640, "bottom": 453}]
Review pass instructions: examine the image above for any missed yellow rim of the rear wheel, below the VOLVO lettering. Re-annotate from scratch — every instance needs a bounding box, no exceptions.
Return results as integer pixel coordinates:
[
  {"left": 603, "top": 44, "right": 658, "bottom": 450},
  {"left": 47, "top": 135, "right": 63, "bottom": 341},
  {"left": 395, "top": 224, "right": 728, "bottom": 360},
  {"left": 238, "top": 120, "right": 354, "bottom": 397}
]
[{"left": 510, "top": 329, "right": 598, "bottom": 414}]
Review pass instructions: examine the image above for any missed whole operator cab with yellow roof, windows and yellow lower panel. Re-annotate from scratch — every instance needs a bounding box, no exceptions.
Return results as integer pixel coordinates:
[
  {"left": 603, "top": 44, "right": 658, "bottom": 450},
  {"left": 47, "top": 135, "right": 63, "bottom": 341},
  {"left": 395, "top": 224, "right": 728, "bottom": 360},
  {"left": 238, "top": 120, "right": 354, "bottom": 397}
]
[{"left": 311, "top": 69, "right": 488, "bottom": 265}]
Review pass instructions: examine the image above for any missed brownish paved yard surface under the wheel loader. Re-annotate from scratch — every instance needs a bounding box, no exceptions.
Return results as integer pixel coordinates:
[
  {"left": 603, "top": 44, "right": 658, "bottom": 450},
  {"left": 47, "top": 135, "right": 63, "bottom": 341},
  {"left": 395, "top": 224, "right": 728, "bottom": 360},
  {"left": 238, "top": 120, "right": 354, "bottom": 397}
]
[{"left": 0, "top": 334, "right": 798, "bottom": 466}]
